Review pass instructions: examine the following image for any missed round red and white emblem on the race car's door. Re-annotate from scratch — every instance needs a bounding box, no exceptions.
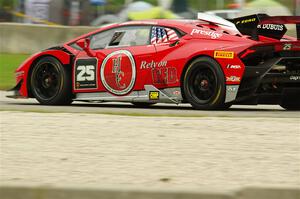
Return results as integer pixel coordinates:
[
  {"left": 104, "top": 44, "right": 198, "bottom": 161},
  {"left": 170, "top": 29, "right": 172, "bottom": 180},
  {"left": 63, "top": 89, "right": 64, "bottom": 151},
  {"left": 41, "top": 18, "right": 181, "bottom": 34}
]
[{"left": 100, "top": 50, "right": 136, "bottom": 95}]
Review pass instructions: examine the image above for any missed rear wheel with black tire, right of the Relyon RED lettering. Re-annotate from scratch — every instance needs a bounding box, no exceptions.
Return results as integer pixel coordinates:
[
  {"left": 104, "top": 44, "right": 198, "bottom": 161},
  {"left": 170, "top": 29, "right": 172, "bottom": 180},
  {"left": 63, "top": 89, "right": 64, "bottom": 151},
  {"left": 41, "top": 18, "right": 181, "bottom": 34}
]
[{"left": 183, "top": 57, "right": 225, "bottom": 110}]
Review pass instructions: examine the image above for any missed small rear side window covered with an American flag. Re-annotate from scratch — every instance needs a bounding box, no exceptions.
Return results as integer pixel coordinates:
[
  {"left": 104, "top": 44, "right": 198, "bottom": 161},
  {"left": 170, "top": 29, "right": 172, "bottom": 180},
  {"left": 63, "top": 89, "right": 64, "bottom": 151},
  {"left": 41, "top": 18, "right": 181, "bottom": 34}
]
[{"left": 151, "top": 26, "right": 179, "bottom": 44}]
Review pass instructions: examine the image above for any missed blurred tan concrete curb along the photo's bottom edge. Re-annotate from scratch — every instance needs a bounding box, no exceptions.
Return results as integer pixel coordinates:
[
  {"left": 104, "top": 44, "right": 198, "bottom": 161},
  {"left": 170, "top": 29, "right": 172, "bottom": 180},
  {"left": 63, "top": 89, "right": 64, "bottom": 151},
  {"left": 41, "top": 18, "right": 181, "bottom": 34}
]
[{"left": 0, "top": 186, "right": 300, "bottom": 199}]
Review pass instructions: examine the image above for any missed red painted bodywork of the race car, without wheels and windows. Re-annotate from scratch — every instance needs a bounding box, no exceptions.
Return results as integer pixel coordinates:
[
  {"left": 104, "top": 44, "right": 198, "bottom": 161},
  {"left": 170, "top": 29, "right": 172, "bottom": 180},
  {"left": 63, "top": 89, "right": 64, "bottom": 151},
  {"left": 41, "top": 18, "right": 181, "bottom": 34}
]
[{"left": 12, "top": 17, "right": 300, "bottom": 104}]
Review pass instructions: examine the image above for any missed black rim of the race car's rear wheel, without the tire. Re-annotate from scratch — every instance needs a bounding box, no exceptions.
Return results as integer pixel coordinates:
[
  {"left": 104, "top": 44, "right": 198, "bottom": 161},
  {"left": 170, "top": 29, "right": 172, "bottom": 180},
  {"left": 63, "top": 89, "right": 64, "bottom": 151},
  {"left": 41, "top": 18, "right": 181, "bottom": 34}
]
[{"left": 188, "top": 65, "right": 217, "bottom": 104}]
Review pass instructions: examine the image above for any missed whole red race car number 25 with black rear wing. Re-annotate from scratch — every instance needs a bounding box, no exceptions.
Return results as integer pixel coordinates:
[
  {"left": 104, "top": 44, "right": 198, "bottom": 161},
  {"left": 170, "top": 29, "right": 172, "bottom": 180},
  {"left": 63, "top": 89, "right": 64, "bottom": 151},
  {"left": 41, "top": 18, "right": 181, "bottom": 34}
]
[{"left": 8, "top": 14, "right": 300, "bottom": 110}]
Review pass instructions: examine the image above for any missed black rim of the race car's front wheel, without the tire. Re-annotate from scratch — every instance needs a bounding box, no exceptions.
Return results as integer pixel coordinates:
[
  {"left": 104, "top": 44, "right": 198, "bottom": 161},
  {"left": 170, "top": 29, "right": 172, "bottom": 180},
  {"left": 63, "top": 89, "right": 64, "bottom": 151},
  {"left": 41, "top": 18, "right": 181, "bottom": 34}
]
[{"left": 33, "top": 63, "right": 61, "bottom": 100}]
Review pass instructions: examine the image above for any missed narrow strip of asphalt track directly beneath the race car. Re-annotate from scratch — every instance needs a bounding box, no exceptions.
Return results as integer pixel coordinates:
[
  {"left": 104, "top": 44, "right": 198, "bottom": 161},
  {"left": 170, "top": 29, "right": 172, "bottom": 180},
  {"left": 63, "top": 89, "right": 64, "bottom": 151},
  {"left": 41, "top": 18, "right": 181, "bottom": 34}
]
[{"left": 0, "top": 91, "right": 300, "bottom": 118}]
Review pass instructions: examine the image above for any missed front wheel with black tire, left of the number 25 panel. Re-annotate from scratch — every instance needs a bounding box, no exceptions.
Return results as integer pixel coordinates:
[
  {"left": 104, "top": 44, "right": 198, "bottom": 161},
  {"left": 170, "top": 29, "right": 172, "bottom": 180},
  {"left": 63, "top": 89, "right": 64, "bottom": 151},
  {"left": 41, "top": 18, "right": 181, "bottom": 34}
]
[{"left": 30, "top": 56, "right": 72, "bottom": 105}]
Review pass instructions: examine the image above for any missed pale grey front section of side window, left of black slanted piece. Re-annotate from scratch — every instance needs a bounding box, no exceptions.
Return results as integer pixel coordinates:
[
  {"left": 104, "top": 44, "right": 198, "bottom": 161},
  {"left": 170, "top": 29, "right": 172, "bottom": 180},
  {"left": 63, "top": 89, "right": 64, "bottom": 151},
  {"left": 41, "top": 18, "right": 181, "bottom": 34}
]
[{"left": 90, "top": 30, "right": 113, "bottom": 50}]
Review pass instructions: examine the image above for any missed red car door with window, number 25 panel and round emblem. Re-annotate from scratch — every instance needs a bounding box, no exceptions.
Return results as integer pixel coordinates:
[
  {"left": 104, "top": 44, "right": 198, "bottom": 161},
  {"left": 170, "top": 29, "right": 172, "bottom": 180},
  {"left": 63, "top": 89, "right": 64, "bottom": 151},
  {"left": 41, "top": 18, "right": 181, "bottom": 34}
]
[{"left": 74, "top": 25, "right": 156, "bottom": 96}]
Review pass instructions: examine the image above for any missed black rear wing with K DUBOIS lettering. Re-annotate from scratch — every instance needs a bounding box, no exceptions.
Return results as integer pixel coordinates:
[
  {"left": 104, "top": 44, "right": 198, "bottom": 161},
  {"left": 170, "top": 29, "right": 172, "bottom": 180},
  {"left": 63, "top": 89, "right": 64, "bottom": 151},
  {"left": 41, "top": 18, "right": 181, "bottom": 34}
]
[{"left": 231, "top": 14, "right": 300, "bottom": 40}]
